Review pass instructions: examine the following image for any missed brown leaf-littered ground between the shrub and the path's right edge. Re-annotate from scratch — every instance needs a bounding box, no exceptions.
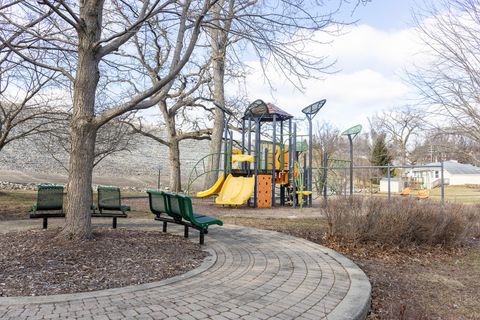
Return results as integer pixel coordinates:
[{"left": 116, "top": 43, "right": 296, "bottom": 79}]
[{"left": 334, "top": 240, "right": 480, "bottom": 320}]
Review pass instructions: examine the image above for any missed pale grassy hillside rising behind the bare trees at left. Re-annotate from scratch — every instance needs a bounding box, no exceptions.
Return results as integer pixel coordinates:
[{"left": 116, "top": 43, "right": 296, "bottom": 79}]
[{"left": 0, "top": 130, "right": 208, "bottom": 188}]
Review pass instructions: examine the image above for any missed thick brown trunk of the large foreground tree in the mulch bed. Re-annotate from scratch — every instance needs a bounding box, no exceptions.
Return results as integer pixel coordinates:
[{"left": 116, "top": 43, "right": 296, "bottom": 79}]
[{"left": 59, "top": 1, "right": 103, "bottom": 240}]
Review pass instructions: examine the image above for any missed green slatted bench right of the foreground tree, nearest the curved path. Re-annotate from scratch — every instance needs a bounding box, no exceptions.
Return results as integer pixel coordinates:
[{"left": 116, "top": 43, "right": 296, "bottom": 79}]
[{"left": 147, "top": 190, "right": 223, "bottom": 244}]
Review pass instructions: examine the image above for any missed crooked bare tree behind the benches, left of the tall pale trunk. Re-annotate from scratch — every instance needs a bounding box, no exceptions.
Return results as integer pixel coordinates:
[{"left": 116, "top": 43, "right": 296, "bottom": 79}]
[{"left": 112, "top": 16, "right": 213, "bottom": 191}]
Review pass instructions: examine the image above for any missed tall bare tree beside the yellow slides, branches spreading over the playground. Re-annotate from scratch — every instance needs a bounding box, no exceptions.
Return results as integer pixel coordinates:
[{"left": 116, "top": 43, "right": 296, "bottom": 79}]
[{"left": 205, "top": 0, "right": 352, "bottom": 187}]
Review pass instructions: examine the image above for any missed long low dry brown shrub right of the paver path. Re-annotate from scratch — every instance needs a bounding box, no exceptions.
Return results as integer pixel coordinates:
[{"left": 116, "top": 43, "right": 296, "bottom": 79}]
[{"left": 325, "top": 197, "right": 480, "bottom": 246}]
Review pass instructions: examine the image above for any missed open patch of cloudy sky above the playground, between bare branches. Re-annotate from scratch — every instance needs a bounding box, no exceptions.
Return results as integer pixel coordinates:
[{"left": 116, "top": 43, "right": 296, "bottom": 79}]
[{"left": 238, "top": 0, "right": 425, "bottom": 134}]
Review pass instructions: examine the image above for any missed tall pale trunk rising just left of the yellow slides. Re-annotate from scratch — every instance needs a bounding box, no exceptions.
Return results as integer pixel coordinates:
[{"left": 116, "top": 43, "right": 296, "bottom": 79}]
[{"left": 204, "top": 4, "right": 227, "bottom": 189}]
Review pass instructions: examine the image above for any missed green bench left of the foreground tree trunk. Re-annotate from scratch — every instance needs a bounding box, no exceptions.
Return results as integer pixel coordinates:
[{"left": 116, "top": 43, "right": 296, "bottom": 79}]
[{"left": 30, "top": 185, "right": 65, "bottom": 229}]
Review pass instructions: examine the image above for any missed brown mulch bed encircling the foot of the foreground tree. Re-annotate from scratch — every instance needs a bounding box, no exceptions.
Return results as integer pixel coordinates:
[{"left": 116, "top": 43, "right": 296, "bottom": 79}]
[{"left": 0, "top": 228, "right": 208, "bottom": 297}]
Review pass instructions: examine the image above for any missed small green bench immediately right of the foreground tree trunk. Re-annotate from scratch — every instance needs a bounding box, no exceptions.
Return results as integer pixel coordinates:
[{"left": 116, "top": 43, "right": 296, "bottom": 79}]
[{"left": 92, "top": 187, "right": 130, "bottom": 229}]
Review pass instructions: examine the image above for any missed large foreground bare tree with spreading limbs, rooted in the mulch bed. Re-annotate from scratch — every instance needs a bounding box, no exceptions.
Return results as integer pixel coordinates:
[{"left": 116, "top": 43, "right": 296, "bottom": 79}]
[{"left": 0, "top": 0, "right": 216, "bottom": 239}]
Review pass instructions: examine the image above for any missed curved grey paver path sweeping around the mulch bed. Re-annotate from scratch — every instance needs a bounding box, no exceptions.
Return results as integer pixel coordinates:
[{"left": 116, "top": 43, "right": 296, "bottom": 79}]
[{"left": 0, "top": 222, "right": 371, "bottom": 320}]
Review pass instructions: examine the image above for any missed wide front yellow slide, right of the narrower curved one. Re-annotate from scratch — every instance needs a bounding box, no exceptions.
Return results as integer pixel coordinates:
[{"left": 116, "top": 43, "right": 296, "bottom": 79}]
[{"left": 215, "top": 174, "right": 255, "bottom": 205}]
